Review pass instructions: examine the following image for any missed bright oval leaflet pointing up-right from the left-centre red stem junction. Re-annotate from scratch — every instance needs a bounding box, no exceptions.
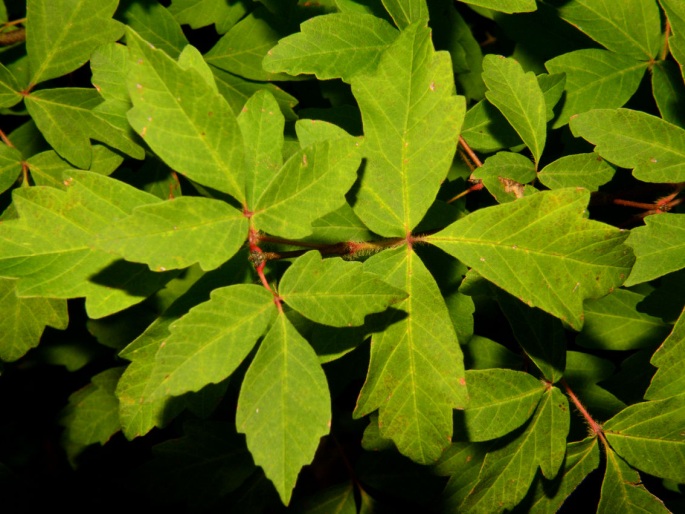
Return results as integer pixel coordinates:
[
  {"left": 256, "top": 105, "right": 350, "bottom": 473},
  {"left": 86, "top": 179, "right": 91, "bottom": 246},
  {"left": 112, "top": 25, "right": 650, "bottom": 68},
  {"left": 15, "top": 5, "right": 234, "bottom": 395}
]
[{"left": 252, "top": 136, "right": 361, "bottom": 239}]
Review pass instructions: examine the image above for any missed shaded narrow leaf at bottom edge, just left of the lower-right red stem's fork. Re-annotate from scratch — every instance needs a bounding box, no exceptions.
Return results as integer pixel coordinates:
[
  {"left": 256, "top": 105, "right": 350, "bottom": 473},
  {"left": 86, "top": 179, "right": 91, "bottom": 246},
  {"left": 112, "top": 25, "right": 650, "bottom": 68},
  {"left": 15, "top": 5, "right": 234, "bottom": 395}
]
[{"left": 524, "top": 437, "right": 599, "bottom": 514}]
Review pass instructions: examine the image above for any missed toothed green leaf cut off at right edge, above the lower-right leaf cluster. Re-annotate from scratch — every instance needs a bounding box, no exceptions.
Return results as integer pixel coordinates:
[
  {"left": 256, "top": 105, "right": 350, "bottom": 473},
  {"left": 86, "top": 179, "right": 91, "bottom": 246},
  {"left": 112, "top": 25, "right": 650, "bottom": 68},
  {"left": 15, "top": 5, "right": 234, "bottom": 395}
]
[{"left": 645, "top": 311, "right": 685, "bottom": 400}]
